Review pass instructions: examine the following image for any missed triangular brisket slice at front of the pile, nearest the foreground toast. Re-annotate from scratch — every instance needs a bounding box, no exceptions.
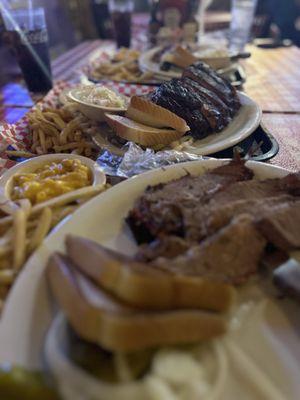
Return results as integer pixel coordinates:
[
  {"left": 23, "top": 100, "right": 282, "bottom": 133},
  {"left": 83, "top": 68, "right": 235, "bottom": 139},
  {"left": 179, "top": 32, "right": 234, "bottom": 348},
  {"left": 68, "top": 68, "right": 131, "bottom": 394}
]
[{"left": 150, "top": 215, "right": 266, "bottom": 284}]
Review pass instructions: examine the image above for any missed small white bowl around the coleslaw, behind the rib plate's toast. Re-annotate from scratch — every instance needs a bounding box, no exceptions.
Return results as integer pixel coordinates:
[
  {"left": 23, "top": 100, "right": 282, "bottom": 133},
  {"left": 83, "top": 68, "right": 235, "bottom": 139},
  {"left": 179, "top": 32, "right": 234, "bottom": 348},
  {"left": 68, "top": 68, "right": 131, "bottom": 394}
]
[{"left": 66, "top": 85, "right": 129, "bottom": 122}]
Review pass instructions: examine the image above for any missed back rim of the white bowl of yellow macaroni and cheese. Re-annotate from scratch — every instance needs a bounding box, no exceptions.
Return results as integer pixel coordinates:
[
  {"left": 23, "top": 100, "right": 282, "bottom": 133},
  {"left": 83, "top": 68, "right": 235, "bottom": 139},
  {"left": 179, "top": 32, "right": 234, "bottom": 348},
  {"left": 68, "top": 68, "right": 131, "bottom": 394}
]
[{"left": 0, "top": 154, "right": 106, "bottom": 202}]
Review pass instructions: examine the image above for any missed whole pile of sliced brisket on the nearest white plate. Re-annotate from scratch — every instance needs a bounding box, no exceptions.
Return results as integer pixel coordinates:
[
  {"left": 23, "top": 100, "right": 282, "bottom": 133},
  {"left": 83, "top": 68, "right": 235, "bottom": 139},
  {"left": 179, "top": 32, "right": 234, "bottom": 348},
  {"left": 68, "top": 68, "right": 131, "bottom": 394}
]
[{"left": 128, "top": 160, "right": 300, "bottom": 285}]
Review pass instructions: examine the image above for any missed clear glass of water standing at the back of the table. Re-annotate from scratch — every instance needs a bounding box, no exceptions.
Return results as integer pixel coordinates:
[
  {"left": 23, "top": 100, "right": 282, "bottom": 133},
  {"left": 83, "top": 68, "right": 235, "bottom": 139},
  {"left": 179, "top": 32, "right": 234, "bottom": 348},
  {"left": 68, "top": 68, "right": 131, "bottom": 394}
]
[{"left": 229, "top": 0, "right": 257, "bottom": 53}]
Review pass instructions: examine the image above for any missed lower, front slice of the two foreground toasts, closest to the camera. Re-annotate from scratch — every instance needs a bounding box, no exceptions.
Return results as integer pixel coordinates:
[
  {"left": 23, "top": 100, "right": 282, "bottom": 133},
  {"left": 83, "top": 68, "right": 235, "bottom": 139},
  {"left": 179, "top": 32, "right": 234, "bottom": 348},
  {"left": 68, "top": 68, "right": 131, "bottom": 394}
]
[{"left": 47, "top": 254, "right": 226, "bottom": 352}]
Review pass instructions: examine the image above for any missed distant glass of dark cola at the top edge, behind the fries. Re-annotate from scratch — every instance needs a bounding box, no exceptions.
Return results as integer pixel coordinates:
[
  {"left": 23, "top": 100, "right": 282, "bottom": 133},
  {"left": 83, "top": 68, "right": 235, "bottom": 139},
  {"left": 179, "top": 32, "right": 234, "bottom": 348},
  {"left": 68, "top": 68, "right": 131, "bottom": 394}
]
[{"left": 109, "top": 0, "right": 134, "bottom": 47}]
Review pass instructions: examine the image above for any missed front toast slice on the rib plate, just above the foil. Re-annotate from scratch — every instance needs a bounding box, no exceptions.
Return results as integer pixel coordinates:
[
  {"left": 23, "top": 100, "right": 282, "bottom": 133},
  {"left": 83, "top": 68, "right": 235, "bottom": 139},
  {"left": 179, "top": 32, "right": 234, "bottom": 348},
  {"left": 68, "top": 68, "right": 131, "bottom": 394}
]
[{"left": 105, "top": 114, "right": 184, "bottom": 146}]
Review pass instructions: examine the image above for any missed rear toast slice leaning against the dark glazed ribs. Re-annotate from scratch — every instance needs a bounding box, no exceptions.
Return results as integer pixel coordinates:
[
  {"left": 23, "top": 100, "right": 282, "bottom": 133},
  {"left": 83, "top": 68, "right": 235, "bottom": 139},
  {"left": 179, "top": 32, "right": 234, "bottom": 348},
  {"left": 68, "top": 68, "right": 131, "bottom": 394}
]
[{"left": 125, "top": 96, "right": 190, "bottom": 133}]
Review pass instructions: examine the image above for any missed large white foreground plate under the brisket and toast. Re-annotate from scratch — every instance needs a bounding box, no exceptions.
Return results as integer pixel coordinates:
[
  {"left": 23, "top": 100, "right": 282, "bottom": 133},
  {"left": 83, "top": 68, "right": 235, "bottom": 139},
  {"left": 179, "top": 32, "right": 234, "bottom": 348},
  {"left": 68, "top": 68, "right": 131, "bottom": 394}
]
[{"left": 0, "top": 159, "right": 300, "bottom": 400}]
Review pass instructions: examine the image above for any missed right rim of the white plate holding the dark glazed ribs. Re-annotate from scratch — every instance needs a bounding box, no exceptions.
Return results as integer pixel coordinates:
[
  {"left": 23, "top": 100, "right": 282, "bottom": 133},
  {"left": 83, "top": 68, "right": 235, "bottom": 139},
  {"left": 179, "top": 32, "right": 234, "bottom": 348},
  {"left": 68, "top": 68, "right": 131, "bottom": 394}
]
[{"left": 179, "top": 92, "right": 262, "bottom": 156}]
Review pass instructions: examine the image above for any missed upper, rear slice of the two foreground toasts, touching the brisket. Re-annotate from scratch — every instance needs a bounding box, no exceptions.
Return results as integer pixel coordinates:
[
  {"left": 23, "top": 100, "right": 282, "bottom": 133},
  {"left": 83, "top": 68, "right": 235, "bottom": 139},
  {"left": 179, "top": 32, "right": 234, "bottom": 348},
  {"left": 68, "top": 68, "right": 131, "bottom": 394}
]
[{"left": 66, "top": 235, "right": 235, "bottom": 312}]
